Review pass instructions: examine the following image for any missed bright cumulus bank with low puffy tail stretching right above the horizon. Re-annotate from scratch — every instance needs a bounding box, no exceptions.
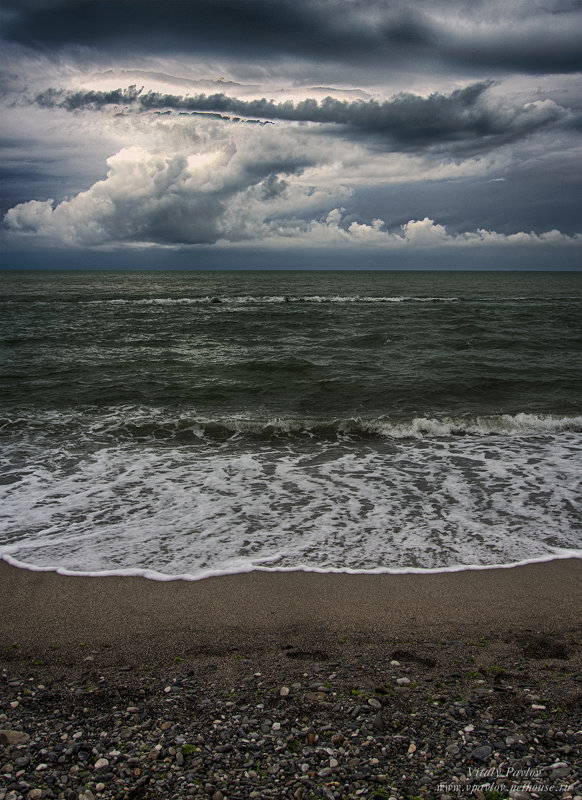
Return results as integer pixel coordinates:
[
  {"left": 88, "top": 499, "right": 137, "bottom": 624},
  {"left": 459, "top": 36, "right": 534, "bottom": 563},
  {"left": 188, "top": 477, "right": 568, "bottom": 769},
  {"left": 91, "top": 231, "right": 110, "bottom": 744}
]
[{"left": 5, "top": 144, "right": 582, "bottom": 249}]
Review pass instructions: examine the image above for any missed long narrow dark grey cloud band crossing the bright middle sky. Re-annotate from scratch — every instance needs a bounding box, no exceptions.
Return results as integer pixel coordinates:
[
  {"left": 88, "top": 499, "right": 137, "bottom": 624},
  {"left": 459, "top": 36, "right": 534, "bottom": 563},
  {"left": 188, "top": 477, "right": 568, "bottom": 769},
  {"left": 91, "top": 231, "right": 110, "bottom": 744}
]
[{"left": 35, "top": 82, "right": 572, "bottom": 152}]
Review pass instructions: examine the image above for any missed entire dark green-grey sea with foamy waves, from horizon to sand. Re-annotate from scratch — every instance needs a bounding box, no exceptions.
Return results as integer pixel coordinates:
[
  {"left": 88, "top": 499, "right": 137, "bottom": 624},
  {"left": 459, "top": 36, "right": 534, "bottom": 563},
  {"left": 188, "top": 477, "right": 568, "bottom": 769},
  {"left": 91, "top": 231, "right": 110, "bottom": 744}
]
[{"left": 0, "top": 272, "right": 582, "bottom": 577}]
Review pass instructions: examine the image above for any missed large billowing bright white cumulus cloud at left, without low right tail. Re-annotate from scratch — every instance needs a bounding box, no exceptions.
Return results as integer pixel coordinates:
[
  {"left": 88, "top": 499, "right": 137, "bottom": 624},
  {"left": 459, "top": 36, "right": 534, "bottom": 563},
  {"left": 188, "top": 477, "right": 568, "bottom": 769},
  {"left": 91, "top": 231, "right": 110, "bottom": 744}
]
[{"left": 5, "top": 140, "right": 349, "bottom": 247}]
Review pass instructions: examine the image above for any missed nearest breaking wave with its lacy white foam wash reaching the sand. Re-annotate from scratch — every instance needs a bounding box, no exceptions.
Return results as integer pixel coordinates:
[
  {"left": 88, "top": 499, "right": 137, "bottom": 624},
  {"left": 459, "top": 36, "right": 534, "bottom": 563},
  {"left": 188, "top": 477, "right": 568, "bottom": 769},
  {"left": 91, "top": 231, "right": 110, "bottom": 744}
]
[{"left": 0, "top": 407, "right": 582, "bottom": 579}]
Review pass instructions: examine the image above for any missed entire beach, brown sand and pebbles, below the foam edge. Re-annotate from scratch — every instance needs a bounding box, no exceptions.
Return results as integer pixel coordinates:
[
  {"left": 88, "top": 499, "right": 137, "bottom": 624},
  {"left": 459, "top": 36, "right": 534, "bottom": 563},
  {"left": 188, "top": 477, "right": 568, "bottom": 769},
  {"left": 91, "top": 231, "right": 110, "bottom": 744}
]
[{"left": 0, "top": 559, "right": 582, "bottom": 800}]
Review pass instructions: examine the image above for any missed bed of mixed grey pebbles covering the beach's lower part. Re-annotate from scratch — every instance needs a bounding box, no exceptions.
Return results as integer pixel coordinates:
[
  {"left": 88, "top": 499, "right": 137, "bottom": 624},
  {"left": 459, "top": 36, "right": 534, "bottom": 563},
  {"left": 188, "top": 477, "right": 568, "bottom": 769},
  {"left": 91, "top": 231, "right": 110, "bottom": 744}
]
[{"left": 0, "top": 645, "right": 582, "bottom": 800}]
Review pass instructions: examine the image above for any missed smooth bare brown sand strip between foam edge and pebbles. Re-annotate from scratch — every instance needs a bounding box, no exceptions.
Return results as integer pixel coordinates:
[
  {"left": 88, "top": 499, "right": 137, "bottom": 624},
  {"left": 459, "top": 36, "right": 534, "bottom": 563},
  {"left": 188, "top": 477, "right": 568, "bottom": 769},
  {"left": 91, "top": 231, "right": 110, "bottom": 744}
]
[{"left": 0, "top": 559, "right": 582, "bottom": 664}]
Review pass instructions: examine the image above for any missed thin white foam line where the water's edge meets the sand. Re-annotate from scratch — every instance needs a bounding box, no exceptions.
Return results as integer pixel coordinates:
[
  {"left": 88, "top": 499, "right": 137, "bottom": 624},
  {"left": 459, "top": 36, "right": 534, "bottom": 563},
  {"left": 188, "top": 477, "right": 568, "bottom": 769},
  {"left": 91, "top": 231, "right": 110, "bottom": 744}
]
[{"left": 0, "top": 548, "right": 582, "bottom": 582}]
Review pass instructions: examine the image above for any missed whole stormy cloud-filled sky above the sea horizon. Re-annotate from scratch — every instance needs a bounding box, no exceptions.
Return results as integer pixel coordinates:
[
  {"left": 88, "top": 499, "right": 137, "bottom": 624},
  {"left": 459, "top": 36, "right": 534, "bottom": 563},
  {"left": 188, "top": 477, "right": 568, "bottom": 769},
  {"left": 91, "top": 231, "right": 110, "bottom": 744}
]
[{"left": 0, "top": 0, "right": 582, "bottom": 270}]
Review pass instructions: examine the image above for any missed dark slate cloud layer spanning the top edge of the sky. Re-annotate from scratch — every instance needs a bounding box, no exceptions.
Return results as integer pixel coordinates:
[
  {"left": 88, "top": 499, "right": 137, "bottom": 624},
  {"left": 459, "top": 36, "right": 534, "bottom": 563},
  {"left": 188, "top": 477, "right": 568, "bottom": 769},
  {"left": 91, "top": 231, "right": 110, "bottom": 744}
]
[{"left": 3, "top": 0, "right": 582, "bottom": 73}]
